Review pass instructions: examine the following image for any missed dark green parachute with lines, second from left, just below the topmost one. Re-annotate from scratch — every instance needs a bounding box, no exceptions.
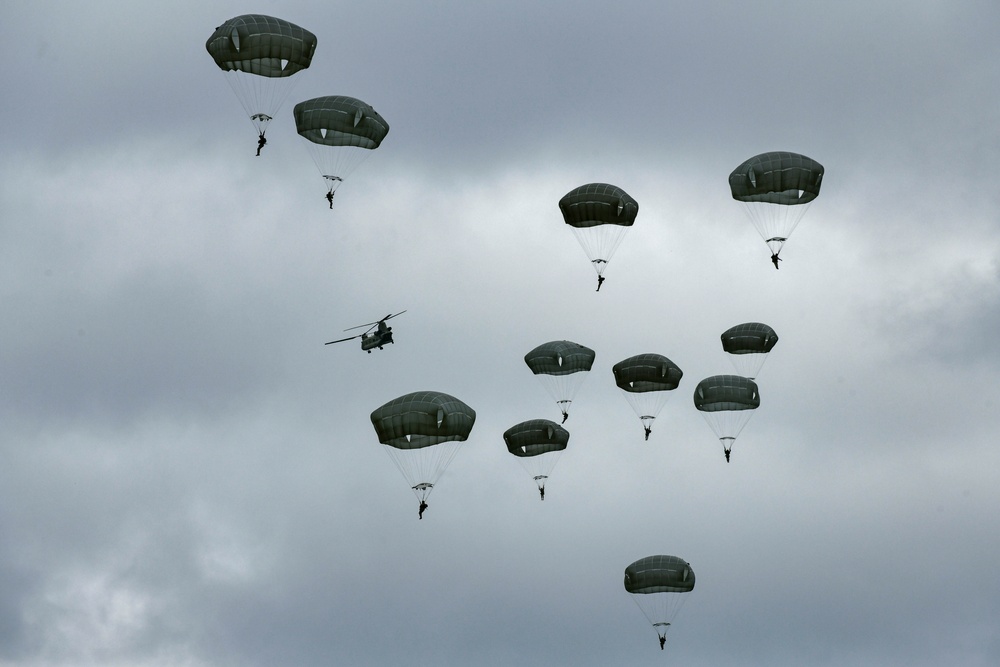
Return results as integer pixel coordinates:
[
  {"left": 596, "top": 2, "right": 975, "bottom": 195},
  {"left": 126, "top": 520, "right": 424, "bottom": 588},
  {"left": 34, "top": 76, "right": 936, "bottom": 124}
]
[{"left": 293, "top": 95, "right": 389, "bottom": 193}]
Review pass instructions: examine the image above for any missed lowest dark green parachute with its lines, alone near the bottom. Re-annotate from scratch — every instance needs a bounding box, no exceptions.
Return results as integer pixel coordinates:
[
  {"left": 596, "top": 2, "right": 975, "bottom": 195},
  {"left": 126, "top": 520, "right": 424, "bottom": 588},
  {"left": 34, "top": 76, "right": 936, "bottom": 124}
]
[{"left": 625, "top": 555, "right": 694, "bottom": 649}]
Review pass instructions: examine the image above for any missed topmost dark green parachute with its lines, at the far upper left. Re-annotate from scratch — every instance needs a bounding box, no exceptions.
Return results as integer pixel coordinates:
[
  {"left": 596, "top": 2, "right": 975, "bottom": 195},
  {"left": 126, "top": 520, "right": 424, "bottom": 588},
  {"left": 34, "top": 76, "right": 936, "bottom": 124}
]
[{"left": 205, "top": 14, "right": 316, "bottom": 142}]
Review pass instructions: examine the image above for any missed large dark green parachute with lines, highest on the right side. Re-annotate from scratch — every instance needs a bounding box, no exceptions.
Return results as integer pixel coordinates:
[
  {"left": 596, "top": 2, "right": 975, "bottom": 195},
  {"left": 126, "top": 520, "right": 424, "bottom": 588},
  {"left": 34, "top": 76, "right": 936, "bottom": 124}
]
[{"left": 729, "top": 151, "right": 823, "bottom": 267}]
